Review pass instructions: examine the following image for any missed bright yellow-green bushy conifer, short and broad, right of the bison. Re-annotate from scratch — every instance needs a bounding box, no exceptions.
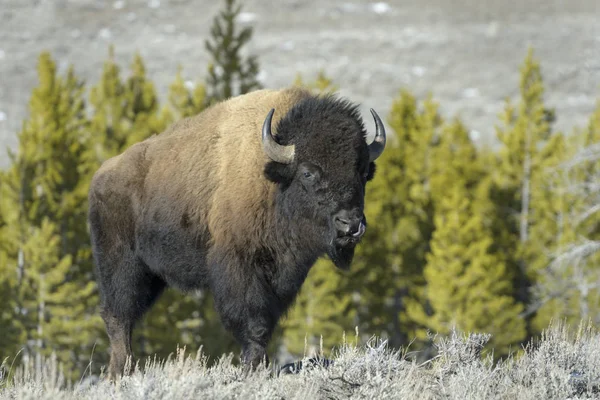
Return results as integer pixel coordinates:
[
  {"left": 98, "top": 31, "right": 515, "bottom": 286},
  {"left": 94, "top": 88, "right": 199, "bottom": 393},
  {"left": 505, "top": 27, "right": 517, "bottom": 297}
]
[{"left": 414, "top": 183, "right": 525, "bottom": 356}]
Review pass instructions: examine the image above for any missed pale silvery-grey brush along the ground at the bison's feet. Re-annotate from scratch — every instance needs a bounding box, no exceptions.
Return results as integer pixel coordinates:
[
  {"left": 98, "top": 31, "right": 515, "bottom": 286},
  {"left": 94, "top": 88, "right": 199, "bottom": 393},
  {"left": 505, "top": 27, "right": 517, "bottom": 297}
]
[{"left": 0, "top": 323, "right": 600, "bottom": 400}]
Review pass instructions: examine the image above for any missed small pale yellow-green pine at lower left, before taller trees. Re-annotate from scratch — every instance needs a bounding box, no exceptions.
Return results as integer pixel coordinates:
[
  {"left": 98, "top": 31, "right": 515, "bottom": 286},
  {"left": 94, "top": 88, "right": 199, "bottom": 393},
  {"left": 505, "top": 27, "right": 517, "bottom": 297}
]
[{"left": 17, "top": 219, "right": 100, "bottom": 379}]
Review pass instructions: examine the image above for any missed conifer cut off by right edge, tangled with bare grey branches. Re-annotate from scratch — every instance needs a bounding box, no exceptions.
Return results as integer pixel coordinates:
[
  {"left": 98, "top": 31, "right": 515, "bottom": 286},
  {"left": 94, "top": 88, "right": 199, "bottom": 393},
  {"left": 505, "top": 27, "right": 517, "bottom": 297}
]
[{"left": 529, "top": 103, "right": 600, "bottom": 329}]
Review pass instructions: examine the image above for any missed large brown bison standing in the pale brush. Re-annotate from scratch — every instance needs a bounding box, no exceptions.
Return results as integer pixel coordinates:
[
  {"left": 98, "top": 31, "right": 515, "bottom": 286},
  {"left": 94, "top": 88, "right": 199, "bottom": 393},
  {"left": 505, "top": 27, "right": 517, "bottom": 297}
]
[{"left": 88, "top": 88, "right": 386, "bottom": 378}]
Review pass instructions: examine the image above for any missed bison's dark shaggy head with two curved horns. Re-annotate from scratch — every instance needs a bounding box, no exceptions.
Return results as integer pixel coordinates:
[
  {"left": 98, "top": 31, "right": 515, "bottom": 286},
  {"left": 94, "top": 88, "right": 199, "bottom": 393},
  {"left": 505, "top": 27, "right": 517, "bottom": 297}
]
[{"left": 262, "top": 96, "right": 386, "bottom": 269}]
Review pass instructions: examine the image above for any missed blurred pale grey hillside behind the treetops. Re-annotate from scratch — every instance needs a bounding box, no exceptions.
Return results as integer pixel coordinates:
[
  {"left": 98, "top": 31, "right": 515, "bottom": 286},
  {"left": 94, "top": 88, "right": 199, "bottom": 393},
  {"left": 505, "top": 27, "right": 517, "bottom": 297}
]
[{"left": 0, "top": 0, "right": 600, "bottom": 167}]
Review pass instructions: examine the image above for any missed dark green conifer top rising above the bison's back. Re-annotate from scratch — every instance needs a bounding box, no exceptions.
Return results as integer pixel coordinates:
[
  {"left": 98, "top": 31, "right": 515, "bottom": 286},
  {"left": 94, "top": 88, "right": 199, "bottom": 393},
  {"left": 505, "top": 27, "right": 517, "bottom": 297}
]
[{"left": 205, "top": 0, "right": 262, "bottom": 105}]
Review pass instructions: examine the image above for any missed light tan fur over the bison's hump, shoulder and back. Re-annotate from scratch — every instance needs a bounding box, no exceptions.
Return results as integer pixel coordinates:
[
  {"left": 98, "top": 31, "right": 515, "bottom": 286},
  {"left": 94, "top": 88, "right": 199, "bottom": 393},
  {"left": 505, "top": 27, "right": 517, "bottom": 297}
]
[{"left": 92, "top": 88, "right": 310, "bottom": 255}]
